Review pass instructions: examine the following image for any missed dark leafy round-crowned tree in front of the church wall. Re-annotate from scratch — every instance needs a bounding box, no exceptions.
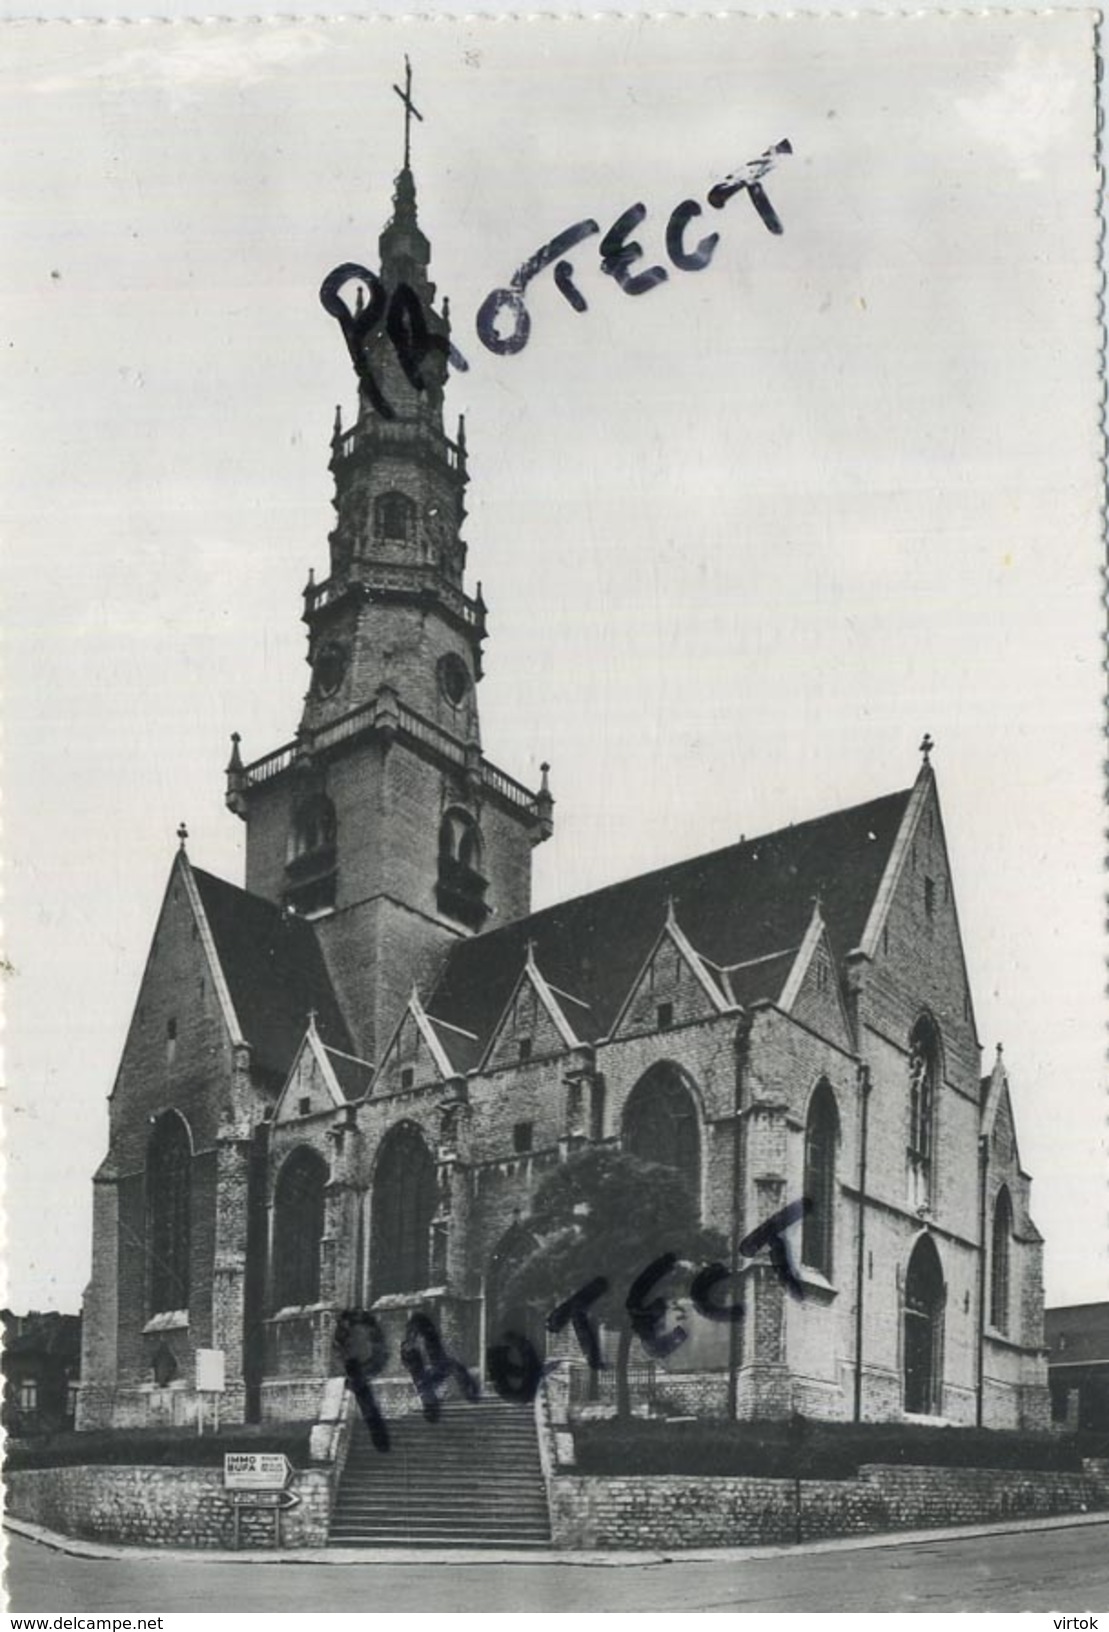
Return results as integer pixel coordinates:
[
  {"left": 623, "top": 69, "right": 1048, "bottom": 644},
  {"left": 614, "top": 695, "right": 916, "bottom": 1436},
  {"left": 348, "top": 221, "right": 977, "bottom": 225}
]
[{"left": 507, "top": 1146, "right": 726, "bottom": 1417}]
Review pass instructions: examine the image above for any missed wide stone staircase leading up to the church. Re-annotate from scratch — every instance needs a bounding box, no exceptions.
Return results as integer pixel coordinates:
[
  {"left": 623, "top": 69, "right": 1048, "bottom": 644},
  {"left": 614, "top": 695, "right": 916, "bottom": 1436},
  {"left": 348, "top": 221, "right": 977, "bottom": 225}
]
[{"left": 328, "top": 1397, "right": 551, "bottom": 1550}]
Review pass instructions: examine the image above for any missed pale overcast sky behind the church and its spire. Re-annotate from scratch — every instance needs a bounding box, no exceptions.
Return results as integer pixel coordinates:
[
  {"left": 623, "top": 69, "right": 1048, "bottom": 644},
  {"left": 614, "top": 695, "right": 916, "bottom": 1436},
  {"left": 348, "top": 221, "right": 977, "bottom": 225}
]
[{"left": 0, "top": 13, "right": 1109, "bottom": 1309}]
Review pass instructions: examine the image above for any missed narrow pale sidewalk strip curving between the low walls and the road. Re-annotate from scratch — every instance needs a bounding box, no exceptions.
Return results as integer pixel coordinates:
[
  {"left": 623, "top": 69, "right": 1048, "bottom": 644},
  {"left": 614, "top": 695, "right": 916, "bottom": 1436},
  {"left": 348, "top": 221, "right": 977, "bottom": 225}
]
[{"left": 3, "top": 1511, "right": 1109, "bottom": 1568}]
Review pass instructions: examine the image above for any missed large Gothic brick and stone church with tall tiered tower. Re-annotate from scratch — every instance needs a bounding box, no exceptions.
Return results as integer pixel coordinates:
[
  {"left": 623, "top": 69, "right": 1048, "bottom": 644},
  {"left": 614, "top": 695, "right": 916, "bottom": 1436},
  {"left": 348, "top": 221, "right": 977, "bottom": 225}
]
[{"left": 77, "top": 92, "right": 1049, "bottom": 1428}]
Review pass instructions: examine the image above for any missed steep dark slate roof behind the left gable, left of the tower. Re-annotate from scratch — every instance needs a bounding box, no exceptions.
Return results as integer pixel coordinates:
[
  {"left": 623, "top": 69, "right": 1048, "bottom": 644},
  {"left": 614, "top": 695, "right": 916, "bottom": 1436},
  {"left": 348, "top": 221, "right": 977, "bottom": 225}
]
[{"left": 192, "top": 867, "right": 352, "bottom": 1092}]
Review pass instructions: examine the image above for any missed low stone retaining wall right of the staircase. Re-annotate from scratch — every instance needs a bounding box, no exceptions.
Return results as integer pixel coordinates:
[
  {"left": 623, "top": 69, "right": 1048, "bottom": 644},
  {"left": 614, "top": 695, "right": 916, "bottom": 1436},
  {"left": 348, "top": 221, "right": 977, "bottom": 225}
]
[{"left": 548, "top": 1466, "right": 1109, "bottom": 1549}]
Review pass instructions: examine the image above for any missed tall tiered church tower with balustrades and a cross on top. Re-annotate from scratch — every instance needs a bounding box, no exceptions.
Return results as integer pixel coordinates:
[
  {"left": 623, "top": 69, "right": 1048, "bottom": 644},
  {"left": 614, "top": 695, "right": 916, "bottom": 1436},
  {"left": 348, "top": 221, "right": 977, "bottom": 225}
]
[{"left": 227, "top": 70, "right": 553, "bottom": 1059}]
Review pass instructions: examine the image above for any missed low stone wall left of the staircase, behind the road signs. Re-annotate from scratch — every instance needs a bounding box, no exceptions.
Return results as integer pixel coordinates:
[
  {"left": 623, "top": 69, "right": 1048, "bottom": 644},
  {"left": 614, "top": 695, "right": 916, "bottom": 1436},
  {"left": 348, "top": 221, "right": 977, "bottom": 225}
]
[{"left": 7, "top": 1467, "right": 331, "bottom": 1549}]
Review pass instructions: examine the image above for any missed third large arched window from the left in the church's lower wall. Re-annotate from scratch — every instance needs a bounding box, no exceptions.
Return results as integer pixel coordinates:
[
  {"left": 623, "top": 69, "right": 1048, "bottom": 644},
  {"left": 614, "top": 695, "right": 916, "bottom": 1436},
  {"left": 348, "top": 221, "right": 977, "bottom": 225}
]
[{"left": 370, "top": 1123, "right": 439, "bottom": 1297}]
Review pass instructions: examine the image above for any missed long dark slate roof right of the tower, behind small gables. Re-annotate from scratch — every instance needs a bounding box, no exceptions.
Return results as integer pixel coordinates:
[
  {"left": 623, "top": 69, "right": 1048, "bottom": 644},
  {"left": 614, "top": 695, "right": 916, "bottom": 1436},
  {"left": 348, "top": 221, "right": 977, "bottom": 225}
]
[{"left": 426, "top": 788, "right": 912, "bottom": 1064}]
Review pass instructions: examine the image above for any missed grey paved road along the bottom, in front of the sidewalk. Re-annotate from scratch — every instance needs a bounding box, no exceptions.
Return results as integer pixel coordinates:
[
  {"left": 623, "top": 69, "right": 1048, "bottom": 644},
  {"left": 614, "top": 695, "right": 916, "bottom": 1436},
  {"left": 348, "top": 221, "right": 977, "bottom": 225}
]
[{"left": 5, "top": 1524, "right": 1109, "bottom": 1614}]
